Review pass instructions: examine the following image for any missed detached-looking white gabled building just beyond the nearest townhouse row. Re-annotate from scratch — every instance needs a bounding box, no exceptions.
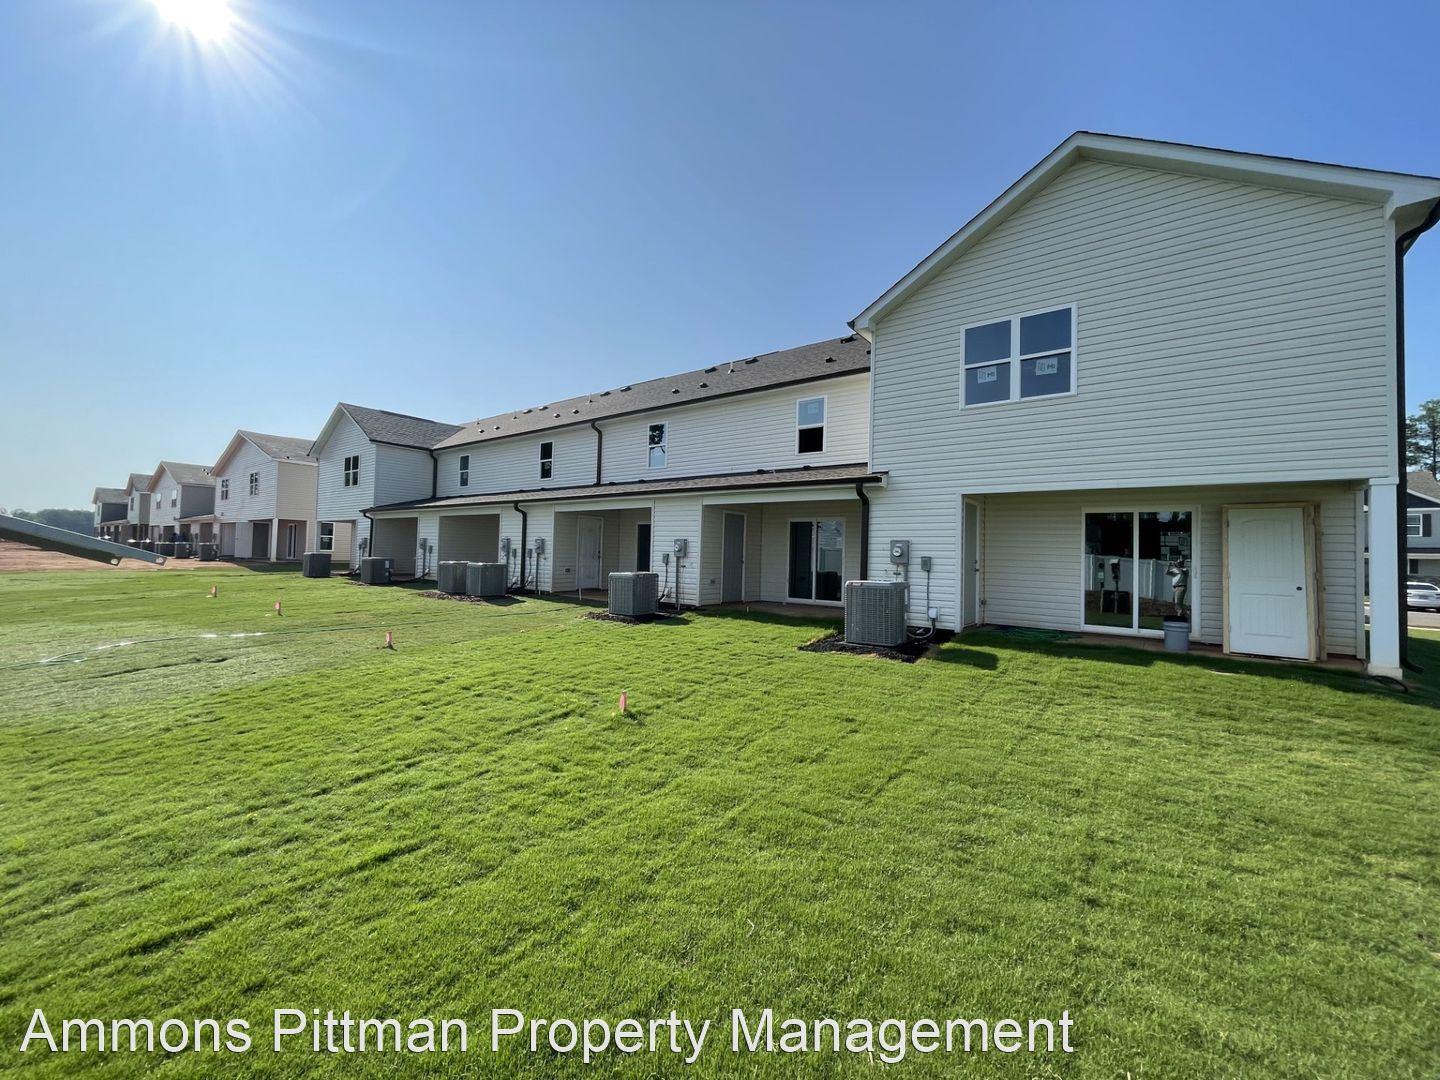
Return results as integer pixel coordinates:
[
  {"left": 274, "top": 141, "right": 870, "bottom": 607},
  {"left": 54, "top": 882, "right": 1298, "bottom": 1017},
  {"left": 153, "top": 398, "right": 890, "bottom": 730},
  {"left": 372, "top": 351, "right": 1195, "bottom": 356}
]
[{"left": 210, "top": 431, "right": 315, "bottom": 562}]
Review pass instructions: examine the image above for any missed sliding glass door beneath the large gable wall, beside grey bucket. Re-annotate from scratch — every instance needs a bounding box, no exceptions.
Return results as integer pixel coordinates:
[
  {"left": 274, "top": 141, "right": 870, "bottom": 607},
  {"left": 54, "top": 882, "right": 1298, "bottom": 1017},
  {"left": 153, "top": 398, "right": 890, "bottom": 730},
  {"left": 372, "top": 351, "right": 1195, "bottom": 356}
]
[{"left": 1081, "top": 510, "right": 1195, "bottom": 634}]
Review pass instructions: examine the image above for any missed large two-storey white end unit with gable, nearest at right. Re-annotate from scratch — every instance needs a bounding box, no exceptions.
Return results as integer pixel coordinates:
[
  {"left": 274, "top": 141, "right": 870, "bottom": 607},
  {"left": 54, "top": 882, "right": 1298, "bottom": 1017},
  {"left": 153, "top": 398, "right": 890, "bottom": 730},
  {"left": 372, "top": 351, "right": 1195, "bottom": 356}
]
[{"left": 852, "top": 132, "right": 1440, "bottom": 675}]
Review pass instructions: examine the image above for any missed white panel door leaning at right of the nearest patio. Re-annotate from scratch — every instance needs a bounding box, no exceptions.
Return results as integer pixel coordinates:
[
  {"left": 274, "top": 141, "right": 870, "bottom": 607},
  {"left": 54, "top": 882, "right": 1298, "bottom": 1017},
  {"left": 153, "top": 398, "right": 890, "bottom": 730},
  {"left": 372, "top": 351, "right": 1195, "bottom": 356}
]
[{"left": 1225, "top": 507, "right": 1313, "bottom": 660}]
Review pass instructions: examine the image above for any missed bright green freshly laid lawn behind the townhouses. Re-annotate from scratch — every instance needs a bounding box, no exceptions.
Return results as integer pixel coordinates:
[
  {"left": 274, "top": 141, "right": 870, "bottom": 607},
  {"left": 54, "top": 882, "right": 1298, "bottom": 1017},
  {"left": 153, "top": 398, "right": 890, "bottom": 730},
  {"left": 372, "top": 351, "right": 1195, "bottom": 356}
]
[{"left": 0, "top": 570, "right": 1440, "bottom": 1077}]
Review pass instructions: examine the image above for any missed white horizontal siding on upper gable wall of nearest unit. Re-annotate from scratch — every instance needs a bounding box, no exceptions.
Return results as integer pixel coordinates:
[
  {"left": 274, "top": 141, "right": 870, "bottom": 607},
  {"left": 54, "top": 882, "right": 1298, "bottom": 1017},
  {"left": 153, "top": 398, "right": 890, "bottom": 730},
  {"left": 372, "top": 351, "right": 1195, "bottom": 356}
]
[{"left": 873, "top": 161, "right": 1394, "bottom": 498}]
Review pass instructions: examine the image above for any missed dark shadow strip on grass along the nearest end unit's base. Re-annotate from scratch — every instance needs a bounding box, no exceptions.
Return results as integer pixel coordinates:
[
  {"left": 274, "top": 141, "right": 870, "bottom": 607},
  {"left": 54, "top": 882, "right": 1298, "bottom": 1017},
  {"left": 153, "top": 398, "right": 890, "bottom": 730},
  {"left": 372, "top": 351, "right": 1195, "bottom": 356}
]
[{"left": 933, "top": 631, "right": 1440, "bottom": 708}]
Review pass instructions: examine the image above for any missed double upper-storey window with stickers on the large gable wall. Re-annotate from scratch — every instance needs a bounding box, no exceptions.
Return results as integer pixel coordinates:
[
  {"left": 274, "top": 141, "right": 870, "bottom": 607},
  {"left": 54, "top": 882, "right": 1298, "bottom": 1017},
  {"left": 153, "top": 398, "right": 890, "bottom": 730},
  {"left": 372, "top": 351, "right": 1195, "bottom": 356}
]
[{"left": 960, "top": 304, "right": 1076, "bottom": 408}]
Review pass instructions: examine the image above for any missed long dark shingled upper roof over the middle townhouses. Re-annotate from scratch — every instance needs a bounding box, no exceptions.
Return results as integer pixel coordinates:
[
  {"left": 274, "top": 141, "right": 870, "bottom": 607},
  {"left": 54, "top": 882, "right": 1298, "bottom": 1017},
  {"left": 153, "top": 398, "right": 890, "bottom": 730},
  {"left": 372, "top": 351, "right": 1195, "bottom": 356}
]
[{"left": 436, "top": 334, "right": 870, "bottom": 448}]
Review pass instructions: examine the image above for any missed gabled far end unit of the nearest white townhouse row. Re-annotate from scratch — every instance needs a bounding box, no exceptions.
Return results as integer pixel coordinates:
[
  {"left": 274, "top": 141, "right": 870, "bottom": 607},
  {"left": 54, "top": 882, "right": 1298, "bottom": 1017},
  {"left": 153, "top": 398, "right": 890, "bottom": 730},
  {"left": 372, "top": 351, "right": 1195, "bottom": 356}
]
[{"left": 310, "top": 402, "right": 459, "bottom": 564}]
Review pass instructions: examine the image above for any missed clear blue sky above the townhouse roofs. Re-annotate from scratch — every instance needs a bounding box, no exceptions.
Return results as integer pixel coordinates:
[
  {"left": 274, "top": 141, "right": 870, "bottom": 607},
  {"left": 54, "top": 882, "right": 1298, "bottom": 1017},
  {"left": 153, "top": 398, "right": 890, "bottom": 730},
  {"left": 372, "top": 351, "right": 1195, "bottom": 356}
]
[{"left": 0, "top": 0, "right": 1440, "bottom": 508}]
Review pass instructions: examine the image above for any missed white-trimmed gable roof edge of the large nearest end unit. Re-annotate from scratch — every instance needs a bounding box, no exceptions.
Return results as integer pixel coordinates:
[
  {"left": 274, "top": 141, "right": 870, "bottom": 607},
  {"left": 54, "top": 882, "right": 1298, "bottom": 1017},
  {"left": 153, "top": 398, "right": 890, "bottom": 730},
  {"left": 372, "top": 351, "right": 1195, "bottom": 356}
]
[{"left": 850, "top": 131, "right": 1440, "bottom": 336}]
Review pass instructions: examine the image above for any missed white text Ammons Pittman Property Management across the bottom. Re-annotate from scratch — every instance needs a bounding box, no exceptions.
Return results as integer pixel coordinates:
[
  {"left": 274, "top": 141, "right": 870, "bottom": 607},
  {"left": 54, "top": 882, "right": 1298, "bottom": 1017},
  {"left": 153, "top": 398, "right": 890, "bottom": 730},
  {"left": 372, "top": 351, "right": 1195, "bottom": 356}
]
[{"left": 19, "top": 1008, "right": 1074, "bottom": 1064}]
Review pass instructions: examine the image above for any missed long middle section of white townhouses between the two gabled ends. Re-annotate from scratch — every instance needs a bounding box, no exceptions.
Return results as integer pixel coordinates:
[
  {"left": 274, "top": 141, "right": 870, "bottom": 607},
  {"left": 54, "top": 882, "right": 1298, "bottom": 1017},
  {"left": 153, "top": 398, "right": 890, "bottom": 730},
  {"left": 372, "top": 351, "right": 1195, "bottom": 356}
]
[{"left": 372, "top": 336, "right": 883, "bottom": 606}]
